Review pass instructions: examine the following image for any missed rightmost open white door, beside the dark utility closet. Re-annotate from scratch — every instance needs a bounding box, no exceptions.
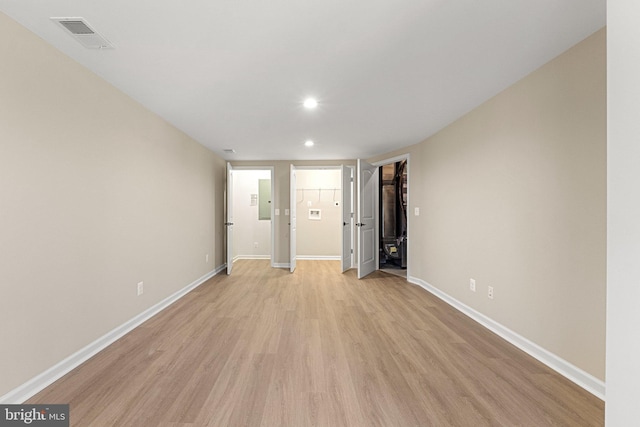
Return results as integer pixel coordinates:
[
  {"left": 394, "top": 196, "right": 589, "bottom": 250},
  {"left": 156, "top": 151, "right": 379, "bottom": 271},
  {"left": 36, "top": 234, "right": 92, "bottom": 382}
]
[{"left": 356, "top": 159, "right": 378, "bottom": 279}]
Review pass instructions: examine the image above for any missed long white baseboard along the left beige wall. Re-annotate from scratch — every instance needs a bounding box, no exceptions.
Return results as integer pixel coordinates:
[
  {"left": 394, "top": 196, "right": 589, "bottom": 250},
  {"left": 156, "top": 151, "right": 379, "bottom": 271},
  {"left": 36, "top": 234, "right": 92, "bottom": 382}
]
[{"left": 0, "top": 264, "right": 227, "bottom": 405}]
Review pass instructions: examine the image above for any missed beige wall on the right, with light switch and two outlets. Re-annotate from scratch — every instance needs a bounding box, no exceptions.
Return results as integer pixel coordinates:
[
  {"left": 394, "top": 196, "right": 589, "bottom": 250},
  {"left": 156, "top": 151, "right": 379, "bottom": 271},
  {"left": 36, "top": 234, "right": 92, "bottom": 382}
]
[{"left": 370, "top": 30, "right": 606, "bottom": 380}]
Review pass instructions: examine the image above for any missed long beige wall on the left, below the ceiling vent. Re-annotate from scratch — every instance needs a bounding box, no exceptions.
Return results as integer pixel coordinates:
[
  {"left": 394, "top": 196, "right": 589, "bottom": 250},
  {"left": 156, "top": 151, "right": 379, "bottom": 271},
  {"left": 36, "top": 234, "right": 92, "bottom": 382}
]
[{"left": 0, "top": 10, "right": 225, "bottom": 396}]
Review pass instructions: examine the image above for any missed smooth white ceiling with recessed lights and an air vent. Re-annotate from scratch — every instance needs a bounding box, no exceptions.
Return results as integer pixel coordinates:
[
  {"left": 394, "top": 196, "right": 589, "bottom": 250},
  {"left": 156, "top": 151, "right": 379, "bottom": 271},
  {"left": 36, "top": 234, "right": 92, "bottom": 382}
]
[{"left": 0, "top": 0, "right": 605, "bottom": 160}]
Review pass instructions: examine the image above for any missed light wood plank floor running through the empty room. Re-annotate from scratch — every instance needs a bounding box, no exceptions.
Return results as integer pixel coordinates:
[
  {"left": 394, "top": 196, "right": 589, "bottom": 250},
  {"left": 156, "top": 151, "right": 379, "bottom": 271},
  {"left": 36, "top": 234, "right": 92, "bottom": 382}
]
[{"left": 30, "top": 260, "right": 604, "bottom": 427}]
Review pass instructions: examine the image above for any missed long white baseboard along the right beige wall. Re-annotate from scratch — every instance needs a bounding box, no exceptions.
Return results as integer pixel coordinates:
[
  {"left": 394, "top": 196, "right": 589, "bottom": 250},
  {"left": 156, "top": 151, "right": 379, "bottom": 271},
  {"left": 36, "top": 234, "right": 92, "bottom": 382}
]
[{"left": 407, "top": 277, "right": 606, "bottom": 401}]
